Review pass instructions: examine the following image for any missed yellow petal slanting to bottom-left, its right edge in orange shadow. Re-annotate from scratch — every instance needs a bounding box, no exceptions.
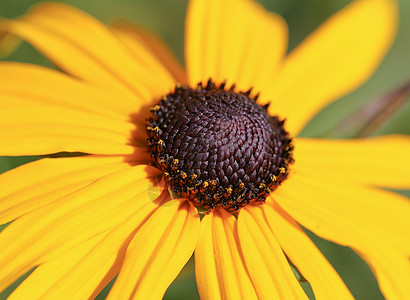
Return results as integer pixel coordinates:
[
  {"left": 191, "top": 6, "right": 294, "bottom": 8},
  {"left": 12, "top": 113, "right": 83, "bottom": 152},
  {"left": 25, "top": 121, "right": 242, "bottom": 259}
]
[{"left": 12, "top": 194, "right": 170, "bottom": 300}]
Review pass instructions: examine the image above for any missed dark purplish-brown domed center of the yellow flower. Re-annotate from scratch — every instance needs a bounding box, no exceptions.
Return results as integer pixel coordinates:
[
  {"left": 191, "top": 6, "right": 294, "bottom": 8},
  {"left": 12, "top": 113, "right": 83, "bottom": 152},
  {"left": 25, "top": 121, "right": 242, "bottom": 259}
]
[{"left": 147, "top": 81, "right": 293, "bottom": 211}]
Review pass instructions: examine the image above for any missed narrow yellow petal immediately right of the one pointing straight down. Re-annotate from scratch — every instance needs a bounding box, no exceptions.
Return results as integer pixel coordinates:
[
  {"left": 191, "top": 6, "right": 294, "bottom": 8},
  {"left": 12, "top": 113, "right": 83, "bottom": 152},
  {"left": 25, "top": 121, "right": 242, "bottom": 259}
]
[{"left": 238, "top": 206, "right": 308, "bottom": 300}]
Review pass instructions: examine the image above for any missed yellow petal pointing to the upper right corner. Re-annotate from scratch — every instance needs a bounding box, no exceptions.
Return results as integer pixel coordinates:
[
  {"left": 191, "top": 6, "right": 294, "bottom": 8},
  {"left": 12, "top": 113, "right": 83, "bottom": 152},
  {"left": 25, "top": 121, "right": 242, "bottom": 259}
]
[{"left": 268, "top": 0, "right": 398, "bottom": 134}]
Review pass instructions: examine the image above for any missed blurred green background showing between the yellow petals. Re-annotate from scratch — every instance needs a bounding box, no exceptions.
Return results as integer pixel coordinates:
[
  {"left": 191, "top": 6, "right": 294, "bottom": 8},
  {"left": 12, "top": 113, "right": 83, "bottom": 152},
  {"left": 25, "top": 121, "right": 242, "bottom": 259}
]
[{"left": 0, "top": 0, "right": 410, "bottom": 300}]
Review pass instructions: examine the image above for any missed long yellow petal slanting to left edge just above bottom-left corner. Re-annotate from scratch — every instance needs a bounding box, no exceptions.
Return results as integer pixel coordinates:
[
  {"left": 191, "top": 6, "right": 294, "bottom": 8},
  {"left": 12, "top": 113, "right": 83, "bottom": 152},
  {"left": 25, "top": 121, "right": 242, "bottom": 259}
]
[{"left": 0, "top": 165, "right": 159, "bottom": 290}]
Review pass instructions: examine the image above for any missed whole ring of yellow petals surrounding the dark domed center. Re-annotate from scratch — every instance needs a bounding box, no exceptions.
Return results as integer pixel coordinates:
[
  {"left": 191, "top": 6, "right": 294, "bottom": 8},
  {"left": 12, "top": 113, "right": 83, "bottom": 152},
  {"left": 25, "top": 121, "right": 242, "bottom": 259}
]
[{"left": 0, "top": 0, "right": 410, "bottom": 299}]
